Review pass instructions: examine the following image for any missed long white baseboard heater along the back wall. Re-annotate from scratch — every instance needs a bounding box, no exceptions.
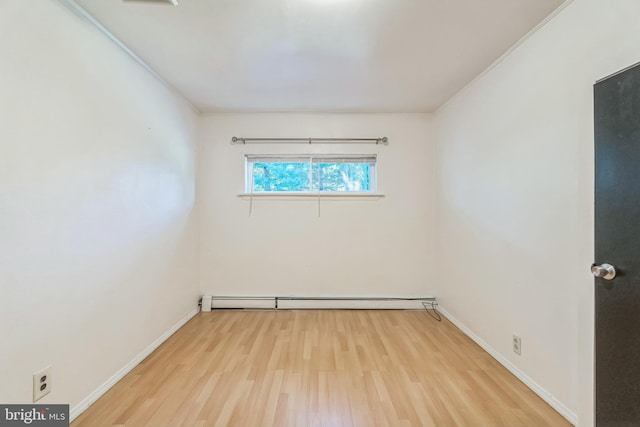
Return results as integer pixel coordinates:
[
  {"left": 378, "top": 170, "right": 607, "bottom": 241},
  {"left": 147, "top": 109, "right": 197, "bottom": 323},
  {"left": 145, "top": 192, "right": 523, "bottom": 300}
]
[{"left": 201, "top": 295, "right": 437, "bottom": 311}]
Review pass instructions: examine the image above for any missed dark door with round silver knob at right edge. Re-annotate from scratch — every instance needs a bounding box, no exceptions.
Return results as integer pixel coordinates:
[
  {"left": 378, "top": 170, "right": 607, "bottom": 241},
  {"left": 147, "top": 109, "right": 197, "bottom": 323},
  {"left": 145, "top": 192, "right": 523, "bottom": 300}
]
[{"left": 592, "top": 66, "right": 640, "bottom": 427}]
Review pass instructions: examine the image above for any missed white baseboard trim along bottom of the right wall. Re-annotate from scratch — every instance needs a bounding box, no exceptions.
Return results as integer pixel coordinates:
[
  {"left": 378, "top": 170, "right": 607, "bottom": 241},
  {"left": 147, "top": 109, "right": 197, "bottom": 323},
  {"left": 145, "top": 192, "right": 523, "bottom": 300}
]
[{"left": 438, "top": 306, "right": 578, "bottom": 426}]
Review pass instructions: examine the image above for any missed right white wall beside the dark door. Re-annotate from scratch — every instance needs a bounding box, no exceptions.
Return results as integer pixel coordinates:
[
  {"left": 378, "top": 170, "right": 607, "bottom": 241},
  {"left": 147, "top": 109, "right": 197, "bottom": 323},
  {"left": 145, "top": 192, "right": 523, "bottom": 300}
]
[{"left": 437, "top": 0, "right": 640, "bottom": 426}]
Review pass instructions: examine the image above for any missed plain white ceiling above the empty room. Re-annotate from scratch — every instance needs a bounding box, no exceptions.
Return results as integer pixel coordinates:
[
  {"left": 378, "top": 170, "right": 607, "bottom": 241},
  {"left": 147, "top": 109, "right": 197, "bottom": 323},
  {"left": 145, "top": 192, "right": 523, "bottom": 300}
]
[{"left": 76, "top": 0, "right": 564, "bottom": 112}]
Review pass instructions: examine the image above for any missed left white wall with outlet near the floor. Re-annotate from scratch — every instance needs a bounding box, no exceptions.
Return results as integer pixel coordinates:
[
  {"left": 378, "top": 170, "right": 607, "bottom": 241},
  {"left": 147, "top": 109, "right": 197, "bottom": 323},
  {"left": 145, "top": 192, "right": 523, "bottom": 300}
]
[{"left": 0, "top": 0, "right": 198, "bottom": 414}]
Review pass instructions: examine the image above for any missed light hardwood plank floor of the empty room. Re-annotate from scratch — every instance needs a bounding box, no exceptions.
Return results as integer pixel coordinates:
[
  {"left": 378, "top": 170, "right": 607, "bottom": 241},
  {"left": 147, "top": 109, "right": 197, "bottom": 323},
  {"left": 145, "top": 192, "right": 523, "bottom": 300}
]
[{"left": 72, "top": 310, "right": 570, "bottom": 427}]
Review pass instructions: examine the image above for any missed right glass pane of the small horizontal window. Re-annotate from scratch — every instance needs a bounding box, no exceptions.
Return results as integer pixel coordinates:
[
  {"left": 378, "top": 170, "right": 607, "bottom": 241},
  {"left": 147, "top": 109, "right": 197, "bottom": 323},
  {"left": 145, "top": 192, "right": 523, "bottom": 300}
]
[{"left": 313, "top": 159, "right": 372, "bottom": 191}]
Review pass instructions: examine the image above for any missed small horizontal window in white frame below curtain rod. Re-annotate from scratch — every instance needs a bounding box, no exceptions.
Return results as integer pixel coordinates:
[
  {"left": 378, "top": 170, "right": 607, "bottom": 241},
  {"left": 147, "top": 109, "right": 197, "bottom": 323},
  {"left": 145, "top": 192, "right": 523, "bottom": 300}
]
[{"left": 245, "top": 154, "right": 377, "bottom": 193}]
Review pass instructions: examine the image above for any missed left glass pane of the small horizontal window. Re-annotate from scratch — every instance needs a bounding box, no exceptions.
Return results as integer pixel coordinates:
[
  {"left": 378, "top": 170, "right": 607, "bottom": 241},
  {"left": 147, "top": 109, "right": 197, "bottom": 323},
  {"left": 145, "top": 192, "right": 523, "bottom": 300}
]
[{"left": 253, "top": 160, "right": 309, "bottom": 192}]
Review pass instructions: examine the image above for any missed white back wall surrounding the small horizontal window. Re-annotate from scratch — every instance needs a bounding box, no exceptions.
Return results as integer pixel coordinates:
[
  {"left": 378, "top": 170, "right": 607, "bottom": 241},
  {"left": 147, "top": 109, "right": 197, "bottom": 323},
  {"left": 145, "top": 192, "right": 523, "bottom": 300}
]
[{"left": 198, "top": 114, "right": 434, "bottom": 297}]
